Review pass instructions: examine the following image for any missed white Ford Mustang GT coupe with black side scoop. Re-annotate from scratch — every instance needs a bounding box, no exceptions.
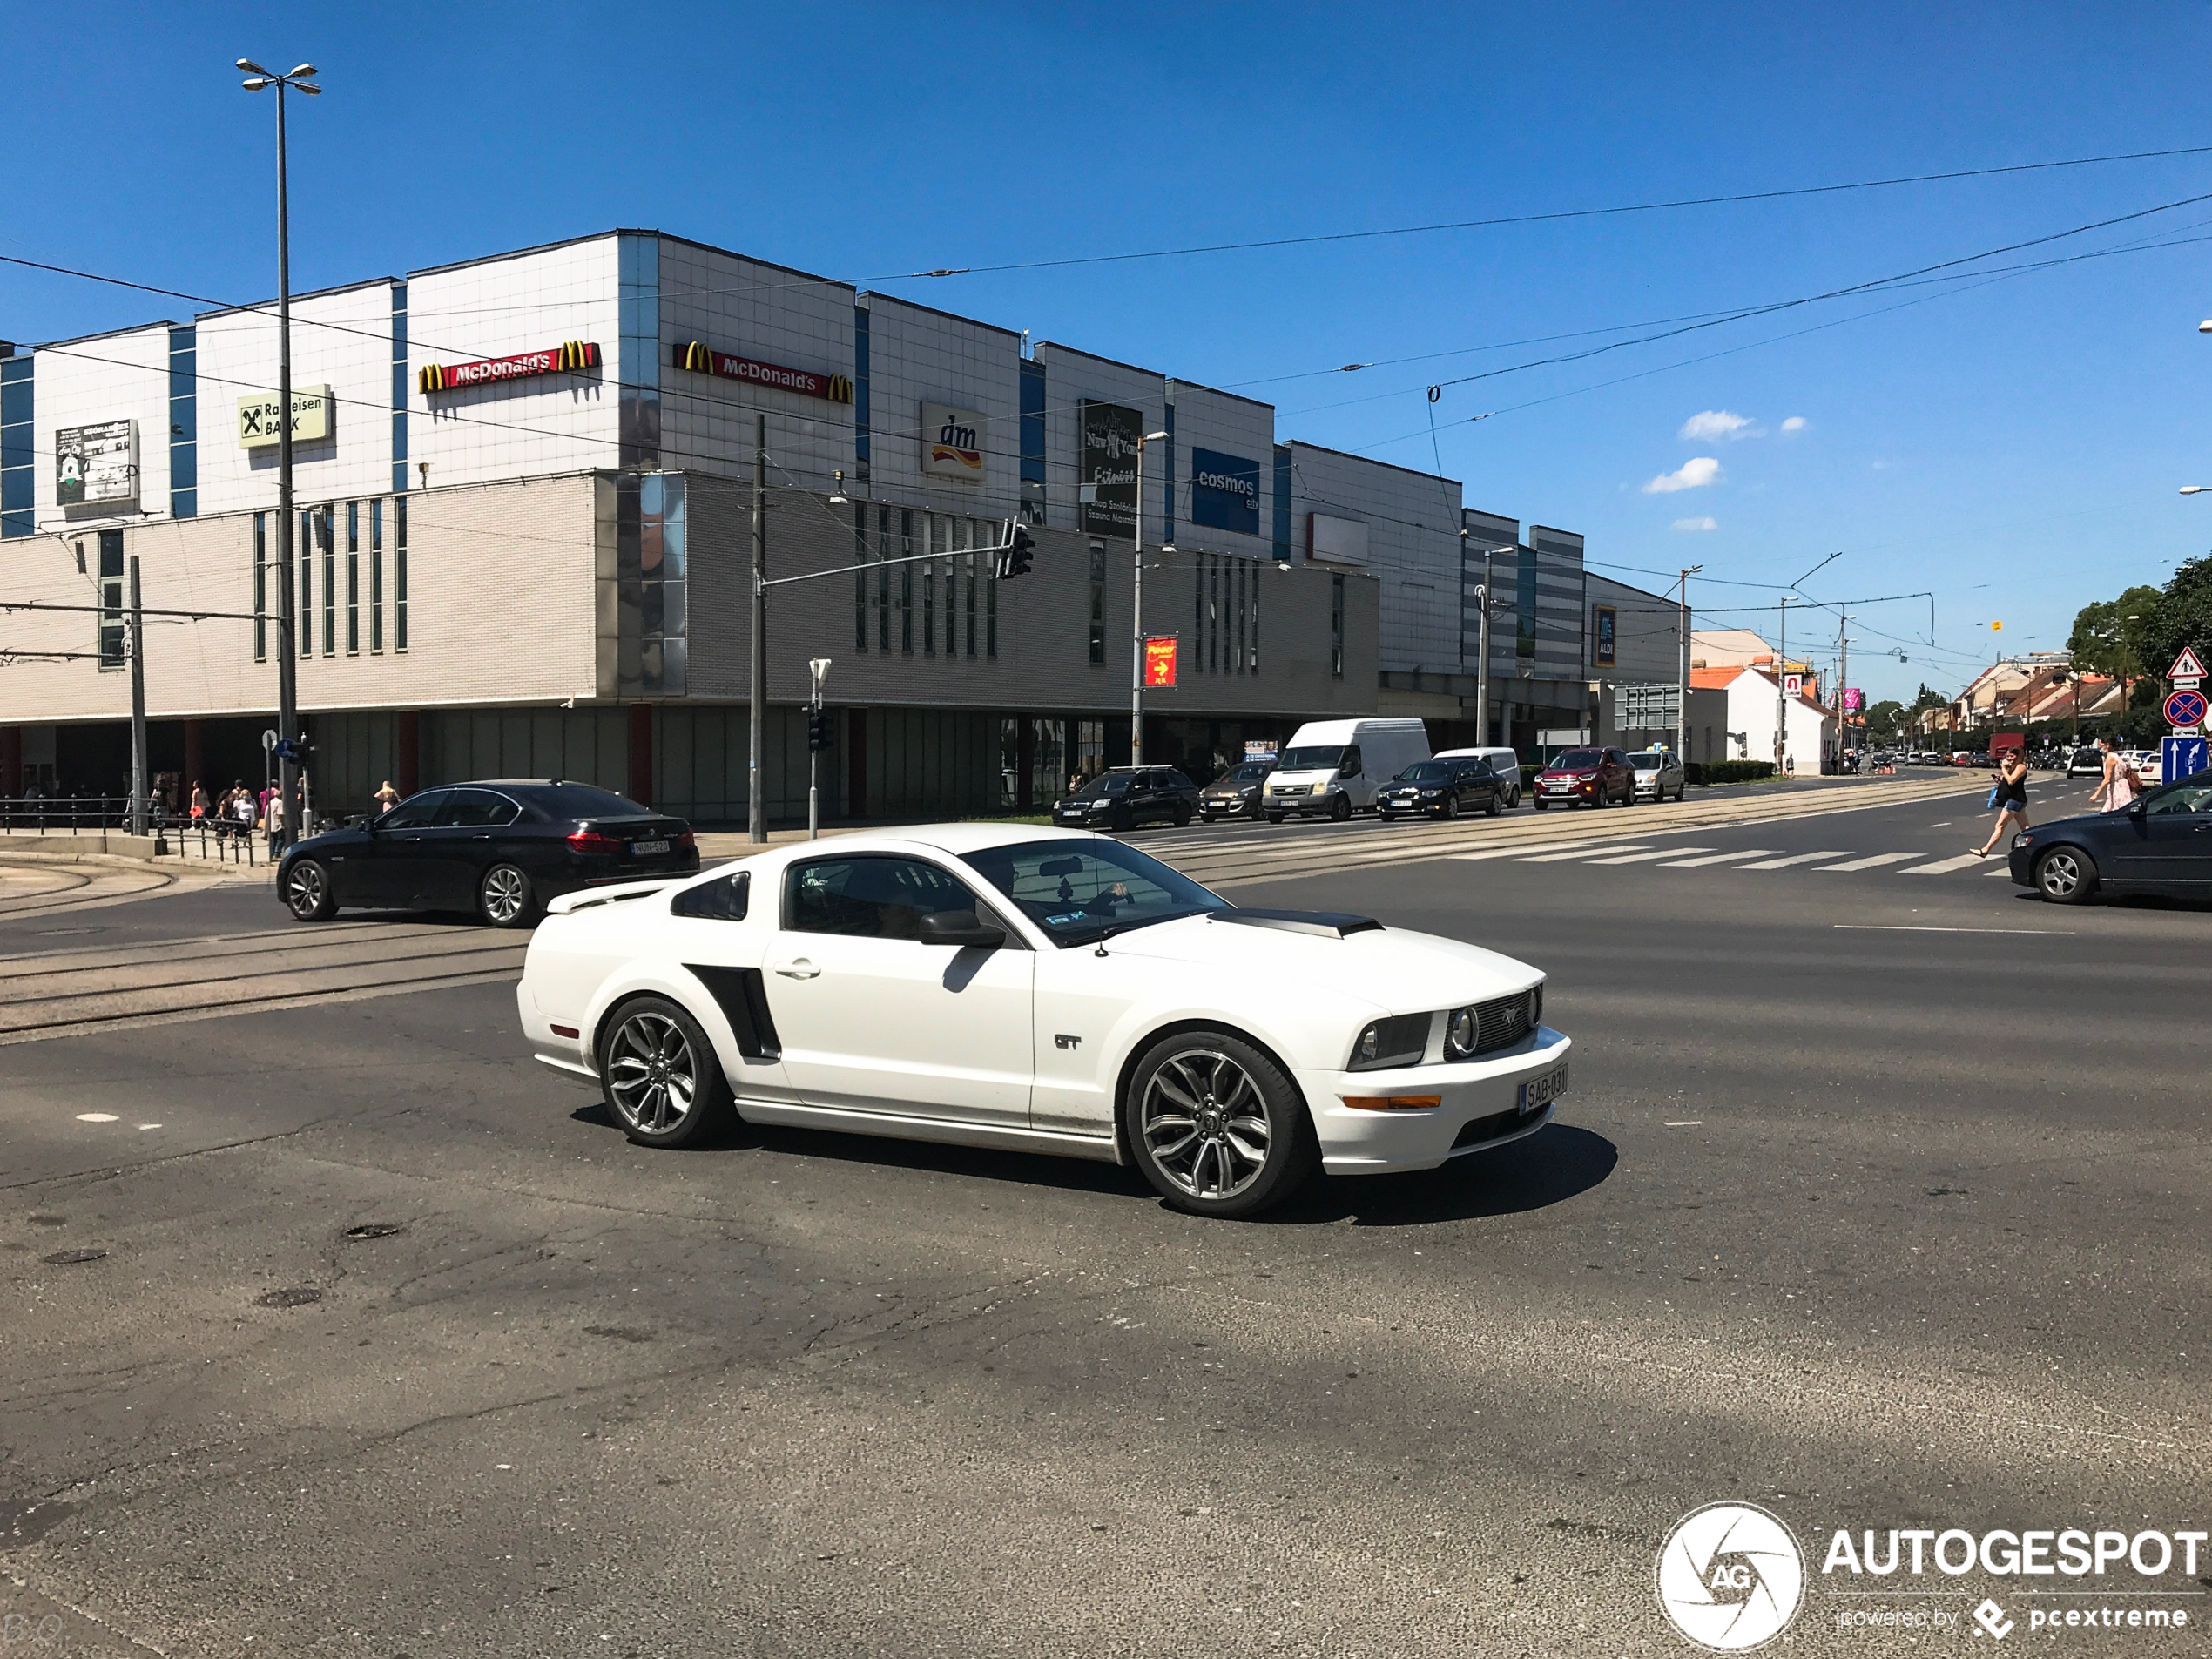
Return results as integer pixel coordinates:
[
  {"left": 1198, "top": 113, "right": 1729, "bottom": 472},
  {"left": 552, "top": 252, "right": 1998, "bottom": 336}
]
[{"left": 516, "top": 825, "right": 1570, "bottom": 1217}]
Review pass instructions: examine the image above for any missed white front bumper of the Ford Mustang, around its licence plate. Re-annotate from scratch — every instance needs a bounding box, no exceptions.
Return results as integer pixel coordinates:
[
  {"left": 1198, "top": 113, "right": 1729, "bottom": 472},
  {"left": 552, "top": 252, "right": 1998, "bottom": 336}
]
[{"left": 1298, "top": 1027, "right": 1575, "bottom": 1175}]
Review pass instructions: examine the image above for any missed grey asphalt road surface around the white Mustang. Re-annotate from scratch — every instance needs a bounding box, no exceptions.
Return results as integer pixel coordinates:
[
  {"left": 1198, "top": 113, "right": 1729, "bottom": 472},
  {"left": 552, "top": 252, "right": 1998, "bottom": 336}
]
[{"left": 0, "top": 783, "right": 2212, "bottom": 1659}]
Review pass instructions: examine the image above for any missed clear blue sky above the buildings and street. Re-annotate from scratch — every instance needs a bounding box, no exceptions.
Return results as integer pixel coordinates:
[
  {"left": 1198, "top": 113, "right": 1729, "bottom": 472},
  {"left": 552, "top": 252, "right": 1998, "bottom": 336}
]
[{"left": 0, "top": 4, "right": 2212, "bottom": 697}]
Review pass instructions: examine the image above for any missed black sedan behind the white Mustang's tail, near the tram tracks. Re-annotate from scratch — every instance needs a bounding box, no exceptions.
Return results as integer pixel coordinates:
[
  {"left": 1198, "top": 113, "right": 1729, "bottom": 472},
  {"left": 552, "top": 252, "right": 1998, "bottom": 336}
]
[{"left": 277, "top": 779, "right": 699, "bottom": 927}]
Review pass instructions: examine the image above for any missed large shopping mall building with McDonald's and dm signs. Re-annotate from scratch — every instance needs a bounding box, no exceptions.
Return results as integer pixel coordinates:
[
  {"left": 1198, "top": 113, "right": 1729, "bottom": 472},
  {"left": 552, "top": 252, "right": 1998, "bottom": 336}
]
[{"left": 0, "top": 230, "right": 1663, "bottom": 823}]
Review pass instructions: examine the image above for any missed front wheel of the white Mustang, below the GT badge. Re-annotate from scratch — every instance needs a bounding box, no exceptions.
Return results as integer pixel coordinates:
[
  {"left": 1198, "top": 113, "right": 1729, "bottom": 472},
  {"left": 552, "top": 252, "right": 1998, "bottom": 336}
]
[{"left": 1122, "top": 1028, "right": 1320, "bottom": 1221}]
